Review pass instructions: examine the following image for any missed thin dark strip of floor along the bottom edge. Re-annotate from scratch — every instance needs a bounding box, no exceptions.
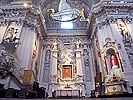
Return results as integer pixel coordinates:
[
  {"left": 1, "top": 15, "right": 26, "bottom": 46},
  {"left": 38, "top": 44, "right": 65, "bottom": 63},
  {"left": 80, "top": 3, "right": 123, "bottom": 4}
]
[{"left": 0, "top": 97, "right": 133, "bottom": 100}]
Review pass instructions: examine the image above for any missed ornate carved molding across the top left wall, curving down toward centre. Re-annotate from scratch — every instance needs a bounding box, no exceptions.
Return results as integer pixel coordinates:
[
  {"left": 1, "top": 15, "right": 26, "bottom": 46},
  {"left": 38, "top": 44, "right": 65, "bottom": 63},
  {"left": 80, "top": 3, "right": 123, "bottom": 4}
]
[{"left": 0, "top": 4, "right": 46, "bottom": 36}]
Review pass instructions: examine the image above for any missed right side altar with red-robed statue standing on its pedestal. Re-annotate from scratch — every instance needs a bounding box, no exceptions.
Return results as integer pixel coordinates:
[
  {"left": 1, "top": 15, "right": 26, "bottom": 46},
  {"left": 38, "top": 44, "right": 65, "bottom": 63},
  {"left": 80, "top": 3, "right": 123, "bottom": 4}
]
[{"left": 105, "top": 55, "right": 131, "bottom": 95}]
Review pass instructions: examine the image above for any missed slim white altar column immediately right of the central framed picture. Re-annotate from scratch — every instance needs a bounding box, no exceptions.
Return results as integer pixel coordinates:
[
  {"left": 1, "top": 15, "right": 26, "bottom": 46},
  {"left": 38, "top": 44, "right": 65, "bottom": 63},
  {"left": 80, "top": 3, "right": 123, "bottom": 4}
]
[{"left": 76, "top": 50, "right": 83, "bottom": 76}]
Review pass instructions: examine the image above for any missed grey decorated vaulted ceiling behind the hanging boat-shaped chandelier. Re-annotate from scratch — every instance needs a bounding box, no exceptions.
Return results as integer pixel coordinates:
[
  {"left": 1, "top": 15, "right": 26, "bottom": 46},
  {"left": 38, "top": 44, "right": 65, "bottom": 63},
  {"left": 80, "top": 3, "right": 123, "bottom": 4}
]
[{"left": 0, "top": 0, "right": 100, "bottom": 17}]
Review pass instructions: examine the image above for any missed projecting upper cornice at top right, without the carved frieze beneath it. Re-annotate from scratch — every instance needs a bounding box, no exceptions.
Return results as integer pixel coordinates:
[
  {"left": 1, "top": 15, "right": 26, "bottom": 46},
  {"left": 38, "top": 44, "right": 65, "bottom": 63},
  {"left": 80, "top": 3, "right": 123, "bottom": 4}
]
[{"left": 92, "top": 1, "right": 133, "bottom": 17}]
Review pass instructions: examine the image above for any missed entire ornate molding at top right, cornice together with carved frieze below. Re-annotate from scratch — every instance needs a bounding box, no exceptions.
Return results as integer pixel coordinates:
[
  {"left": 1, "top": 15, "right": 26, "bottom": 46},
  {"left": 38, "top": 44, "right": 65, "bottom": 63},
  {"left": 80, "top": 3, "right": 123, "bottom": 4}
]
[{"left": 92, "top": 1, "right": 133, "bottom": 28}]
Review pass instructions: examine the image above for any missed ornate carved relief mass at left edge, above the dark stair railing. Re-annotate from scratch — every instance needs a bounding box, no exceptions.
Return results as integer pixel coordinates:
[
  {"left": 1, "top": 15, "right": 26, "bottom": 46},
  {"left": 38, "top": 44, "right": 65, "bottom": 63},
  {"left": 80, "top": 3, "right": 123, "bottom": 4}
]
[{"left": 0, "top": 45, "right": 24, "bottom": 80}]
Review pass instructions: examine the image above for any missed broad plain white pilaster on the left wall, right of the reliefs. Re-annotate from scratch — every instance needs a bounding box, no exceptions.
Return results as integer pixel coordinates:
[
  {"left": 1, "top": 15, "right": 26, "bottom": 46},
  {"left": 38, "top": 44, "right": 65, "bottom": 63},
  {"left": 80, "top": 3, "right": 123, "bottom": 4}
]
[{"left": 17, "top": 27, "right": 35, "bottom": 70}]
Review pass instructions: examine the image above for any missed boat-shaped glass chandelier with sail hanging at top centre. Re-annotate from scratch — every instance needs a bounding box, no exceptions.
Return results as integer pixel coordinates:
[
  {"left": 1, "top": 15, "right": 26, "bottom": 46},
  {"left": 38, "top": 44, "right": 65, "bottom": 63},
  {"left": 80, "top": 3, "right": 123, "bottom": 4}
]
[{"left": 47, "top": 0, "right": 84, "bottom": 22}]
